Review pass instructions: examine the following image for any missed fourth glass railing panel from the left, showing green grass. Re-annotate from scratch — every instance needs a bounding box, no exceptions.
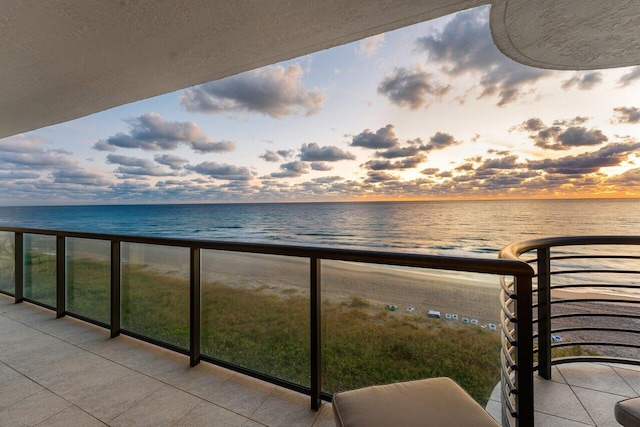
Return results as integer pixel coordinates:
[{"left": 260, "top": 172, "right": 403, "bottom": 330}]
[{"left": 121, "top": 243, "right": 189, "bottom": 349}]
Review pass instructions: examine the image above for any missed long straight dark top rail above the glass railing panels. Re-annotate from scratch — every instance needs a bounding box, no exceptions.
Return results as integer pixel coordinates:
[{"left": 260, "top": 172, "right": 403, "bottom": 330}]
[{"left": 0, "top": 226, "right": 534, "bottom": 276}]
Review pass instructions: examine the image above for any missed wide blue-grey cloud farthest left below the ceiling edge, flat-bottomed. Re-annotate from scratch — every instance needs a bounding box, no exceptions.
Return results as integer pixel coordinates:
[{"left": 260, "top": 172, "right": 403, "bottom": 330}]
[{"left": 93, "top": 113, "right": 235, "bottom": 153}]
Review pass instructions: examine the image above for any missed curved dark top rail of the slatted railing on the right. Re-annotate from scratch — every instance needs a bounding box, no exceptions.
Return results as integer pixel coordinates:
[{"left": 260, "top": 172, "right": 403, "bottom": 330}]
[{"left": 500, "top": 236, "right": 640, "bottom": 260}]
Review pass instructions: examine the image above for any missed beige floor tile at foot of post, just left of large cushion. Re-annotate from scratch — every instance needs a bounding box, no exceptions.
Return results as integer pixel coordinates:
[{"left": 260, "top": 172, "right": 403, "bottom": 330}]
[{"left": 251, "top": 387, "right": 318, "bottom": 427}]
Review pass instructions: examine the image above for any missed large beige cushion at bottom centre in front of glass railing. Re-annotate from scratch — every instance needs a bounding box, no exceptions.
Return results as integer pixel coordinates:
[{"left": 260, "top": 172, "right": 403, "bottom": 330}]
[{"left": 333, "top": 378, "right": 500, "bottom": 427}]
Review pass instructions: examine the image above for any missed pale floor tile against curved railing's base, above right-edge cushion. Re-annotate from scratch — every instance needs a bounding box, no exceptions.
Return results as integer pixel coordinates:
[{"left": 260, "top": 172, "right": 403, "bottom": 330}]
[{"left": 558, "top": 363, "right": 636, "bottom": 397}]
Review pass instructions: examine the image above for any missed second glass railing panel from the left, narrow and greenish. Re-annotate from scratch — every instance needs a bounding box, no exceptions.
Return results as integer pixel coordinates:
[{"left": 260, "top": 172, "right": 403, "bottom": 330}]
[{"left": 24, "top": 234, "right": 56, "bottom": 307}]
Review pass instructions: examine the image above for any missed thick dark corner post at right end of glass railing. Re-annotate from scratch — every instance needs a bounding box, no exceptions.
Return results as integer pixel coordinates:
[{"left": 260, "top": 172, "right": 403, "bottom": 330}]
[{"left": 515, "top": 275, "right": 533, "bottom": 427}]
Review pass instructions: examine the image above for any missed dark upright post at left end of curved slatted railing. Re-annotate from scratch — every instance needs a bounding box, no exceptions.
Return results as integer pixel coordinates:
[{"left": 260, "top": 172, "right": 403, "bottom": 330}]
[{"left": 538, "top": 246, "right": 551, "bottom": 380}]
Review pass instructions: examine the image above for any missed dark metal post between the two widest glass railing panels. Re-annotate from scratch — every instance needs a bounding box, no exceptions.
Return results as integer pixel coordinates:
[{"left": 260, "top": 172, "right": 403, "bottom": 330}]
[{"left": 309, "top": 258, "right": 322, "bottom": 411}]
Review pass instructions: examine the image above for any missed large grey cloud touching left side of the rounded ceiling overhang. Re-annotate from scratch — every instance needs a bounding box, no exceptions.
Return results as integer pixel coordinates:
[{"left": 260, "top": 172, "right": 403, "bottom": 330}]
[{"left": 417, "top": 7, "right": 551, "bottom": 106}]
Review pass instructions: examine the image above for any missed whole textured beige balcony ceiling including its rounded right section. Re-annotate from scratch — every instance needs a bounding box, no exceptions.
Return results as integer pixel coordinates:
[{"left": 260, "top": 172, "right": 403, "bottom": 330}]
[{"left": 0, "top": 0, "right": 640, "bottom": 137}]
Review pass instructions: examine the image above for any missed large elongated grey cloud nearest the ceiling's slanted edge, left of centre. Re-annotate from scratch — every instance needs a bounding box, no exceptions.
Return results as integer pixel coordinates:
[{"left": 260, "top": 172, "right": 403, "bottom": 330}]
[{"left": 180, "top": 64, "right": 326, "bottom": 119}]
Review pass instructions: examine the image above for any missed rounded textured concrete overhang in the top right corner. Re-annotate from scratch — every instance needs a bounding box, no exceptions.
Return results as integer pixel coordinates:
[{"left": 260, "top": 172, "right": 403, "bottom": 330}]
[{"left": 491, "top": 0, "right": 640, "bottom": 70}]
